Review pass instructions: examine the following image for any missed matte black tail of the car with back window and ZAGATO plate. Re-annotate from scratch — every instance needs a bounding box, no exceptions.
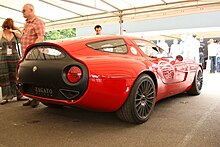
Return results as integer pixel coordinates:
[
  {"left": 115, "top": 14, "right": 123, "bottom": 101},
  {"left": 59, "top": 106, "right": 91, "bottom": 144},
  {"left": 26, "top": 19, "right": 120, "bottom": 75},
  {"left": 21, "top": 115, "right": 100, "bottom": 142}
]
[{"left": 17, "top": 43, "right": 88, "bottom": 103}]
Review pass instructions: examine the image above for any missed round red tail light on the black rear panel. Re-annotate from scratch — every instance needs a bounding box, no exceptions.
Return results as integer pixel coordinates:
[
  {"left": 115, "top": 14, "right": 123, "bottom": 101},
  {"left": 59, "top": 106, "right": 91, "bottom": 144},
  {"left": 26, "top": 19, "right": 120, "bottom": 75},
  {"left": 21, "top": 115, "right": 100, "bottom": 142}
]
[{"left": 67, "top": 66, "right": 82, "bottom": 83}]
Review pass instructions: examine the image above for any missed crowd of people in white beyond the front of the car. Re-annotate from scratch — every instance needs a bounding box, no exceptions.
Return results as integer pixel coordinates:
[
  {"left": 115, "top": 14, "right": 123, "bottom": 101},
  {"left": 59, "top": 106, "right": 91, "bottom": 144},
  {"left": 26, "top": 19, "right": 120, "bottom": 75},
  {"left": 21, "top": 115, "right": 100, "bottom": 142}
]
[{"left": 157, "top": 34, "right": 220, "bottom": 73}]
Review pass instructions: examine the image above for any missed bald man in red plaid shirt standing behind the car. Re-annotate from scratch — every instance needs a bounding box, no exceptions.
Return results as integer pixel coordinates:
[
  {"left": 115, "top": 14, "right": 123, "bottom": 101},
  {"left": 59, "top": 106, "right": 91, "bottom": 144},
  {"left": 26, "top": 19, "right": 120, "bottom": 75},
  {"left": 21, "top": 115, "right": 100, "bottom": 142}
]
[{"left": 21, "top": 4, "right": 45, "bottom": 108}]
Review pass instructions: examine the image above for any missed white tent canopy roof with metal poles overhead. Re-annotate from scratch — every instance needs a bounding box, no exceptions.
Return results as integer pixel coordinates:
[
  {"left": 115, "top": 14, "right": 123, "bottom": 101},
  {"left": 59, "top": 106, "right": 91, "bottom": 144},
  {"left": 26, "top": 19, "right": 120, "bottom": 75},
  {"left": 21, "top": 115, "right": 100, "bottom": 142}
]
[{"left": 0, "top": 0, "right": 220, "bottom": 31}]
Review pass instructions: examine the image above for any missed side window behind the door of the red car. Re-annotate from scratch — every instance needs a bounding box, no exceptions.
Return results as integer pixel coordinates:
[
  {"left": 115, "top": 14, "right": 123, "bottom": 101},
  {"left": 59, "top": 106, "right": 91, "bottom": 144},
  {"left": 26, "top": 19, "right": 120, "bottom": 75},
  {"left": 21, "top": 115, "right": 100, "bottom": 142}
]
[{"left": 87, "top": 39, "right": 128, "bottom": 54}]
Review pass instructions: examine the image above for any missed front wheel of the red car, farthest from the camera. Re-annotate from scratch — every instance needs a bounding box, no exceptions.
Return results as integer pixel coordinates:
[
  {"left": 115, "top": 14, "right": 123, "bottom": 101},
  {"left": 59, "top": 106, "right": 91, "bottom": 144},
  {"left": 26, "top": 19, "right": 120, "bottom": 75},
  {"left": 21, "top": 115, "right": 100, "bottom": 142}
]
[{"left": 187, "top": 67, "right": 203, "bottom": 95}]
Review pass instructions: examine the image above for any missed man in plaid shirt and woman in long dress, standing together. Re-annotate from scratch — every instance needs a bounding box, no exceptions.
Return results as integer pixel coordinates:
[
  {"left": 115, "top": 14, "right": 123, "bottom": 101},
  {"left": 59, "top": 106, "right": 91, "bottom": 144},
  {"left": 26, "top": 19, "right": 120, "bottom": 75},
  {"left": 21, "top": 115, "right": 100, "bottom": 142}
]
[{"left": 0, "top": 4, "right": 45, "bottom": 107}]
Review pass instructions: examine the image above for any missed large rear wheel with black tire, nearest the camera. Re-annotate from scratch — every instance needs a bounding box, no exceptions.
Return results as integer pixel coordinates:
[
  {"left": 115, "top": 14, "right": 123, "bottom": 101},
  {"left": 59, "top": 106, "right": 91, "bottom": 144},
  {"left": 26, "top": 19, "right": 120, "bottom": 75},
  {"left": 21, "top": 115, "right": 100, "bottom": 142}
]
[{"left": 116, "top": 74, "right": 156, "bottom": 124}]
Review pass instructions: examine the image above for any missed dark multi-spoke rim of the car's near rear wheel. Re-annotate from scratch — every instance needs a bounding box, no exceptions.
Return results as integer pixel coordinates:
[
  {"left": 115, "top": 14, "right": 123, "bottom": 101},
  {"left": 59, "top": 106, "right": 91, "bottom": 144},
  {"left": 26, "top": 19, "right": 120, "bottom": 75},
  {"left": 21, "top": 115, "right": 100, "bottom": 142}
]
[{"left": 135, "top": 80, "right": 155, "bottom": 119}]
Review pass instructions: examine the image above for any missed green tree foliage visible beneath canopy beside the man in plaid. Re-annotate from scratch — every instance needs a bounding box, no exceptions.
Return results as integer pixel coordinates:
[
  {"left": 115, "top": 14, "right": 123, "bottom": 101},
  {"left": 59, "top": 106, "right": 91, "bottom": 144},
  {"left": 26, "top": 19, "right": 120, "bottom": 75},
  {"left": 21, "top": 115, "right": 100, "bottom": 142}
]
[{"left": 45, "top": 28, "right": 76, "bottom": 40}]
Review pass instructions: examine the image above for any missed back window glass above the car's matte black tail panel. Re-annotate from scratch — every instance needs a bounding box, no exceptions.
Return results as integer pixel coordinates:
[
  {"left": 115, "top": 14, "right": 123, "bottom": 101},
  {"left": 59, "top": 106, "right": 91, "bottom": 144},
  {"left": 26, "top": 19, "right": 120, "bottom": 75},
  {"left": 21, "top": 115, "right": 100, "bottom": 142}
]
[{"left": 25, "top": 46, "right": 65, "bottom": 60}]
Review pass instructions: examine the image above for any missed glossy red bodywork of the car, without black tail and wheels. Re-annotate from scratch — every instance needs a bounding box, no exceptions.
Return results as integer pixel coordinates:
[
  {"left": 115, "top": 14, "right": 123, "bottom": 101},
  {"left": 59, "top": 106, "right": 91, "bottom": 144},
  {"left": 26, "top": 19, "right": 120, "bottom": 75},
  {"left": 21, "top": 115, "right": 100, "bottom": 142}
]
[{"left": 20, "top": 36, "right": 199, "bottom": 112}]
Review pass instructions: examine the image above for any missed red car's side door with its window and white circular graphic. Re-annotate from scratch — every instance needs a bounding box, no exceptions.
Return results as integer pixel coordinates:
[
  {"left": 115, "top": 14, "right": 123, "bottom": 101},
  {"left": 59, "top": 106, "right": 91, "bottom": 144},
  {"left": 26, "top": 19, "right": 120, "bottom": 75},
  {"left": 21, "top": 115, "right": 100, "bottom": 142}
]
[{"left": 134, "top": 40, "right": 187, "bottom": 84}]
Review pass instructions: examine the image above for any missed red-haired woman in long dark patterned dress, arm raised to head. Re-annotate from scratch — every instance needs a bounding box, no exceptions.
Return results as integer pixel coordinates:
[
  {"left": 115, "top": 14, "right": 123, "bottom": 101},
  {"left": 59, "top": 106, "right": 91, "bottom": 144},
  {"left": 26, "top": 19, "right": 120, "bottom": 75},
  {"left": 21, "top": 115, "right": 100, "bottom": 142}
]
[{"left": 0, "top": 18, "right": 22, "bottom": 105}]
